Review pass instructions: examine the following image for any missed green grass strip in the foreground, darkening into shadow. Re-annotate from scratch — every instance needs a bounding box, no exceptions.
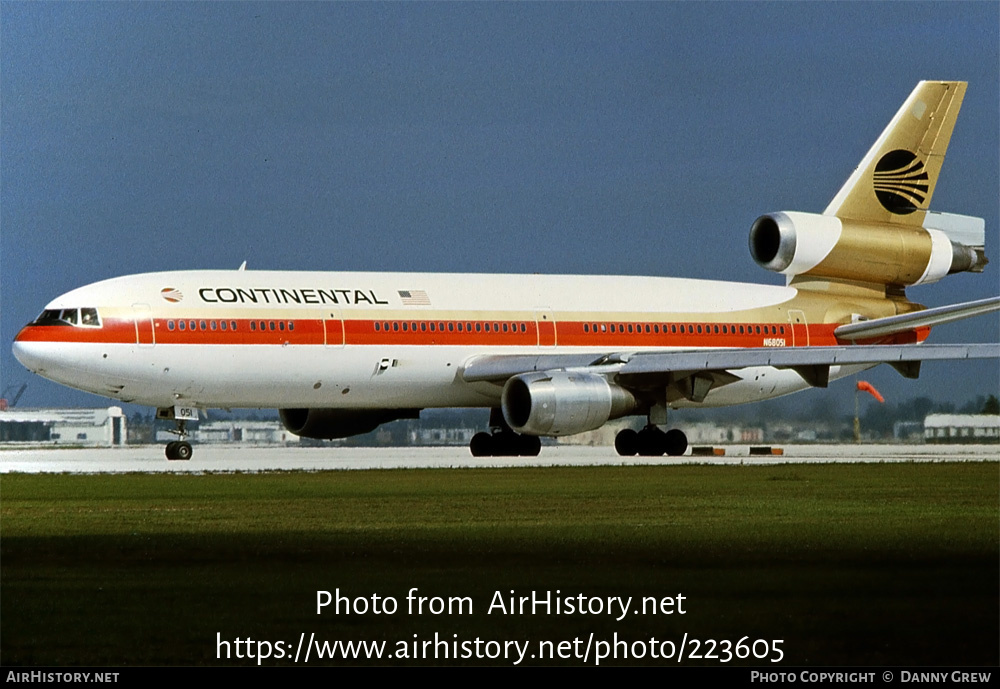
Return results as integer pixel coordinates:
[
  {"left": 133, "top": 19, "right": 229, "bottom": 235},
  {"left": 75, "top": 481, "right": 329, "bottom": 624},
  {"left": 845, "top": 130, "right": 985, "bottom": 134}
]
[{"left": 0, "top": 463, "right": 1000, "bottom": 665}]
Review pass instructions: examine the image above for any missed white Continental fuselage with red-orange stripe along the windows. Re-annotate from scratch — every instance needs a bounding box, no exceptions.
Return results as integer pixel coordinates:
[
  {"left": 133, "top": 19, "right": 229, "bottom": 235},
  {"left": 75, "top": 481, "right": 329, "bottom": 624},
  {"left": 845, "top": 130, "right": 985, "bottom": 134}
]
[{"left": 14, "top": 271, "right": 876, "bottom": 409}]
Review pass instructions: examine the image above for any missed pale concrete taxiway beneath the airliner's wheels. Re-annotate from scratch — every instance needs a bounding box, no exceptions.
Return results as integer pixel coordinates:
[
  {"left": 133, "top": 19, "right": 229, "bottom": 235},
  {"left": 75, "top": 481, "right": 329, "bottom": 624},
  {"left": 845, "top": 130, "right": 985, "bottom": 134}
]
[{"left": 0, "top": 444, "right": 1000, "bottom": 473}]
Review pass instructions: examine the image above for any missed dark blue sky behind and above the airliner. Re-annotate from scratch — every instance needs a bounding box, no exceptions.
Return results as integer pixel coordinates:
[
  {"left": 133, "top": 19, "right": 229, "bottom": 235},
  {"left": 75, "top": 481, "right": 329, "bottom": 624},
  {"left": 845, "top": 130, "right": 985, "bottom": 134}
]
[{"left": 0, "top": 1, "right": 1000, "bottom": 406}]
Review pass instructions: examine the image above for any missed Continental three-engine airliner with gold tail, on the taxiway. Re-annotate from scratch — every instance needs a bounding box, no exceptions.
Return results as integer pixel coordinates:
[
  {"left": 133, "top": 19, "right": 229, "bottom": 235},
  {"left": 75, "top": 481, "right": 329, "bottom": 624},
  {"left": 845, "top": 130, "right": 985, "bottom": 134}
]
[{"left": 13, "top": 81, "right": 1000, "bottom": 459}]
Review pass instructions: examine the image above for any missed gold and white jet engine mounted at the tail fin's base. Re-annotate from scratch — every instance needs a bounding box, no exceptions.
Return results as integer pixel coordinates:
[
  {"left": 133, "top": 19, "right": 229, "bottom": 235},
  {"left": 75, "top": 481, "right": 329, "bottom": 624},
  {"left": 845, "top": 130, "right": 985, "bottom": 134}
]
[{"left": 750, "top": 211, "right": 987, "bottom": 285}]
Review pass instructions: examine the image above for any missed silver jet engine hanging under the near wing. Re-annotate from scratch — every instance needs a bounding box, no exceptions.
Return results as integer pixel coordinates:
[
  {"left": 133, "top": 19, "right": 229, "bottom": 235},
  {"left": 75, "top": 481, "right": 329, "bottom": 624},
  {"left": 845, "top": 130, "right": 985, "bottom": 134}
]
[{"left": 501, "top": 371, "right": 636, "bottom": 436}]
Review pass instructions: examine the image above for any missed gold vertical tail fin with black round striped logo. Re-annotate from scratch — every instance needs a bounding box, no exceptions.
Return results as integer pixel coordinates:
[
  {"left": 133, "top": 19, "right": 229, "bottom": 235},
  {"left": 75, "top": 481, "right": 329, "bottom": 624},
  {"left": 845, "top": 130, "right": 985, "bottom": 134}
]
[{"left": 823, "top": 81, "right": 967, "bottom": 226}]
